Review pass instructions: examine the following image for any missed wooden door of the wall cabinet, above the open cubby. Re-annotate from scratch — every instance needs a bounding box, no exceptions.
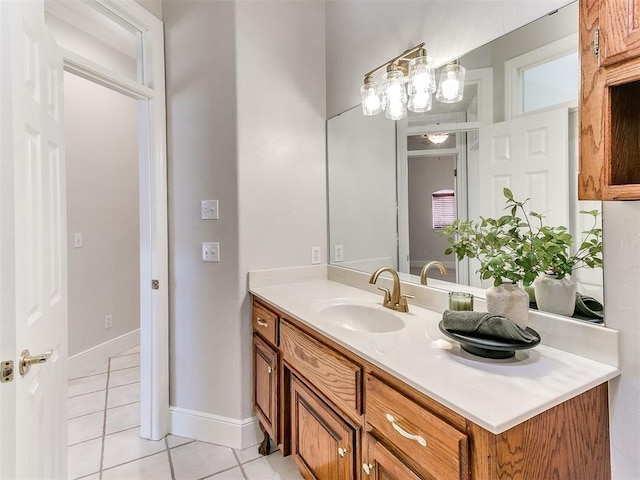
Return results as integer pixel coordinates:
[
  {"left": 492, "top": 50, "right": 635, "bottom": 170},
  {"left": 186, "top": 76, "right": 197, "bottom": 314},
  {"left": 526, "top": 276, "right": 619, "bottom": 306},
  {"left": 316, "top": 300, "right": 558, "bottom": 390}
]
[{"left": 600, "top": 0, "right": 640, "bottom": 66}]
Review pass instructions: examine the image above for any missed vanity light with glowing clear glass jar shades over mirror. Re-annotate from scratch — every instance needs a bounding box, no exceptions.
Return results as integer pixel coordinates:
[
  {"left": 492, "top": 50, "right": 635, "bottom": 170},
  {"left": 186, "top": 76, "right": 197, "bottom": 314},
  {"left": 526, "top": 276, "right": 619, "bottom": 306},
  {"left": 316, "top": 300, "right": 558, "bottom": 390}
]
[{"left": 360, "top": 43, "right": 464, "bottom": 120}]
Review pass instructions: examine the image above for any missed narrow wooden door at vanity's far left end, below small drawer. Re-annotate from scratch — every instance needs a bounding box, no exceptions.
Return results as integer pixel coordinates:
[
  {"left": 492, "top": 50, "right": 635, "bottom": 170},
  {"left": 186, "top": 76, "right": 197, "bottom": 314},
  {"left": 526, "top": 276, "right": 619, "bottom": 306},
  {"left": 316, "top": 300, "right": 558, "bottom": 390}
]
[{"left": 253, "top": 334, "right": 279, "bottom": 443}]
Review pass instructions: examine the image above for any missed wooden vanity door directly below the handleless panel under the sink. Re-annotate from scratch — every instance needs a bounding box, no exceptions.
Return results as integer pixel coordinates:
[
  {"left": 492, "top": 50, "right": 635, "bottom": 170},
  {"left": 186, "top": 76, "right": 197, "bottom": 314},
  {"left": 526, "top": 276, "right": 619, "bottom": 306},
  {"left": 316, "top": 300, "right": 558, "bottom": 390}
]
[{"left": 291, "top": 375, "right": 356, "bottom": 480}]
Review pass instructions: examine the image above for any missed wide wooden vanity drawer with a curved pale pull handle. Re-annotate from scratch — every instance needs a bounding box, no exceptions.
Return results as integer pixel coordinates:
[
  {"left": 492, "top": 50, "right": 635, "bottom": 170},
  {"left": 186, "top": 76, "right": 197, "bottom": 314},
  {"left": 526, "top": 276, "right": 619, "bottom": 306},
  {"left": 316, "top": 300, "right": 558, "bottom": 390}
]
[{"left": 366, "top": 375, "right": 469, "bottom": 480}]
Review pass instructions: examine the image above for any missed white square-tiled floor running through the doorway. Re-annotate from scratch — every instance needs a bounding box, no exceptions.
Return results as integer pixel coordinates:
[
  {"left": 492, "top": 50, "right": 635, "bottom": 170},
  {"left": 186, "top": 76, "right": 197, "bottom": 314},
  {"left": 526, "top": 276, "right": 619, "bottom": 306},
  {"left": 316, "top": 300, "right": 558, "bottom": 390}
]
[{"left": 68, "top": 347, "right": 301, "bottom": 480}]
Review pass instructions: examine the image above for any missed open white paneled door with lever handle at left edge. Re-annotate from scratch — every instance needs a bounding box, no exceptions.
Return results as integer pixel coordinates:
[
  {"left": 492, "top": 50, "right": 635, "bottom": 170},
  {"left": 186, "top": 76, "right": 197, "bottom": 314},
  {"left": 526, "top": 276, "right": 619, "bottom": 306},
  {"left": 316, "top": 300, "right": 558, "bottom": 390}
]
[{"left": 0, "top": 1, "right": 67, "bottom": 478}]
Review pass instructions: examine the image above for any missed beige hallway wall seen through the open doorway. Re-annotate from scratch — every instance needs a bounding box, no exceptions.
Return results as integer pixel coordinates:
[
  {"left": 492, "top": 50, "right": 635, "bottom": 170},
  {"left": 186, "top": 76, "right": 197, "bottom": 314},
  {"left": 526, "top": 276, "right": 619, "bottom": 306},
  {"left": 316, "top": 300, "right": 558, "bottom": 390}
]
[{"left": 64, "top": 73, "right": 140, "bottom": 355}]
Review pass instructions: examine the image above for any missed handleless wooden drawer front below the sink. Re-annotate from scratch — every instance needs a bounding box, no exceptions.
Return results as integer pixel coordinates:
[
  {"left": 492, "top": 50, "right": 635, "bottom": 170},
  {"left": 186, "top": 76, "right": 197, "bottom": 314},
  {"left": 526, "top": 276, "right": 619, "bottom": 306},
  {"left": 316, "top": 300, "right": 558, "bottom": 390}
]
[{"left": 280, "top": 321, "right": 362, "bottom": 415}]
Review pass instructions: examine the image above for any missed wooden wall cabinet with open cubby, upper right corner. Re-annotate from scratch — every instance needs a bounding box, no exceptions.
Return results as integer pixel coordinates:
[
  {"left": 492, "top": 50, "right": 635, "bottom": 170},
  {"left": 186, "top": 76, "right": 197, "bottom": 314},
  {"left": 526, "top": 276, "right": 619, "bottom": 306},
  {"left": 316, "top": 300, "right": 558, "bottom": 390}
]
[{"left": 578, "top": 0, "right": 640, "bottom": 200}]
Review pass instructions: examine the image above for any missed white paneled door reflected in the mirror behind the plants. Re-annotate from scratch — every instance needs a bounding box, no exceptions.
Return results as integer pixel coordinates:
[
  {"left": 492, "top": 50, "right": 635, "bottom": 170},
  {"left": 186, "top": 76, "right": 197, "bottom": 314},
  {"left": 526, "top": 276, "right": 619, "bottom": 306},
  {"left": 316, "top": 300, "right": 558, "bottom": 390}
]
[{"left": 476, "top": 108, "right": 569, "bottom": 227}]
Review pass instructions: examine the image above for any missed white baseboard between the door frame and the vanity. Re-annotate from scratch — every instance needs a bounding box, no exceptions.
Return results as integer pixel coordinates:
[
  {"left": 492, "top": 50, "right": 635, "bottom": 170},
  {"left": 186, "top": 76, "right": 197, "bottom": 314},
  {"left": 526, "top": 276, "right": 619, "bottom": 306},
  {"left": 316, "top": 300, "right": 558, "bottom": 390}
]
[{"left": 169, "top": 407, "right": 262, "bottom": 450}]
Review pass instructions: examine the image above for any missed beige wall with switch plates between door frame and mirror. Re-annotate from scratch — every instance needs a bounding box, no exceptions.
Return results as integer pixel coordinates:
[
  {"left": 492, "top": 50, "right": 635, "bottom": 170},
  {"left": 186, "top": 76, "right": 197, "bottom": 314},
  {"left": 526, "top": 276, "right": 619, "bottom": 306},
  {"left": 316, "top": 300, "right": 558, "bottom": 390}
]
[{"left": 163, "top": 1, "right": 327, "bottom": 419}]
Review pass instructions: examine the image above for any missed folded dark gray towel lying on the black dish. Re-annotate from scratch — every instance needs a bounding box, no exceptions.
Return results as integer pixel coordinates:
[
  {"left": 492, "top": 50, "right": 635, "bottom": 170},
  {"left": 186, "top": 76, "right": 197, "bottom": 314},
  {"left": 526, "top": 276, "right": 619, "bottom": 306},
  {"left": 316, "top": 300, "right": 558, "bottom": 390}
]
[{"left": 442, "top": 310, "right": 538, "bottom": 343}]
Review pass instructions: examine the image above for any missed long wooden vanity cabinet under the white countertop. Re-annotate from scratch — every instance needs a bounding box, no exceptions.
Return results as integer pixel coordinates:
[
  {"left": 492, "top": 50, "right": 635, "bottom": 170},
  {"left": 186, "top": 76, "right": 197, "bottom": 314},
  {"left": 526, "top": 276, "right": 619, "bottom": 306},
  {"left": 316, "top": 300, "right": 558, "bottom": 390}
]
[{"left": 254, "top": 296, "right": 611, "bottom": 480}]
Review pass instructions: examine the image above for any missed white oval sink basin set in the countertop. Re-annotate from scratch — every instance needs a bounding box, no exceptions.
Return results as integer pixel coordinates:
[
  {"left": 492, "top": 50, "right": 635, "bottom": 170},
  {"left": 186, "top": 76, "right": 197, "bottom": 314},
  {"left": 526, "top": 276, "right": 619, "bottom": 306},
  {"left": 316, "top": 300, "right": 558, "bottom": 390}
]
[{"left": 319, "top": 303, "right": 404, "bottom": 333}]
